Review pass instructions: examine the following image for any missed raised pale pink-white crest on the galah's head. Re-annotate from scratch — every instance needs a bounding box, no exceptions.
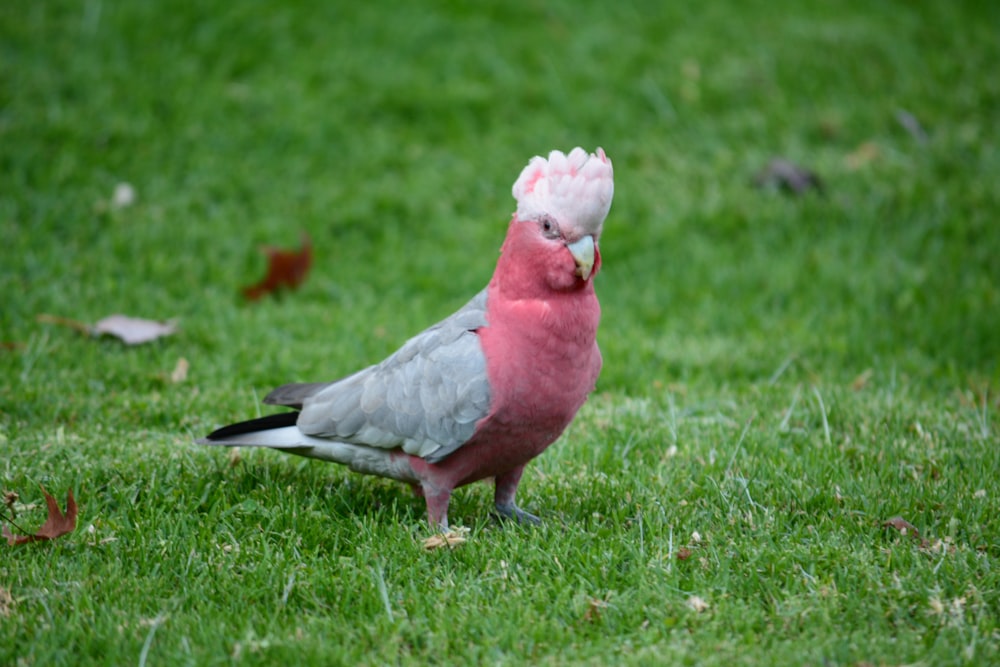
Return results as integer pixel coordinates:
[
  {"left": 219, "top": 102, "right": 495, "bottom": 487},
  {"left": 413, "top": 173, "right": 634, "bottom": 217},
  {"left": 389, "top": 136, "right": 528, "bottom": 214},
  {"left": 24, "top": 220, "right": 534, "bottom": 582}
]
[{"left": 513, "top": 147, "right": 615, "bottom": 239}]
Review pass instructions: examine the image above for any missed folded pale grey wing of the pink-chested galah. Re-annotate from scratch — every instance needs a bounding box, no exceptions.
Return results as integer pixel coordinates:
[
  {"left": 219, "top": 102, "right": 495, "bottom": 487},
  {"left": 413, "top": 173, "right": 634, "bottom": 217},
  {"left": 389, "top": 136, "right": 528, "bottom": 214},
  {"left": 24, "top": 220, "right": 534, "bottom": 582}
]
[{"left": 290, "top": 290, "right": 490, "bottom": 462}]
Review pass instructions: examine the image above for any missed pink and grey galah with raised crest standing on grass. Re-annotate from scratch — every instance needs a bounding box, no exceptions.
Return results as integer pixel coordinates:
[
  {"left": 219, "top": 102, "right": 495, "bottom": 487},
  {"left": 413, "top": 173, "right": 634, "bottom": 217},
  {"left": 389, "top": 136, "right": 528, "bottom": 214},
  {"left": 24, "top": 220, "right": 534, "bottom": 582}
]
[{"left": 198, "top": 148, "right": 614, "bottom": 529}]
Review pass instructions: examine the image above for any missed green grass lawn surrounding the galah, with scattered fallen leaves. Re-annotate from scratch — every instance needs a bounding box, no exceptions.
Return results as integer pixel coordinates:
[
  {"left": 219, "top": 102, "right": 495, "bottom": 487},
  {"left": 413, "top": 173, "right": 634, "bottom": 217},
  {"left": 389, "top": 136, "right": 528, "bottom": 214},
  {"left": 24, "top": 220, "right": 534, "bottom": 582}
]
[{"left": 0, "top": 0, "right": 1000, "bottom": 665}]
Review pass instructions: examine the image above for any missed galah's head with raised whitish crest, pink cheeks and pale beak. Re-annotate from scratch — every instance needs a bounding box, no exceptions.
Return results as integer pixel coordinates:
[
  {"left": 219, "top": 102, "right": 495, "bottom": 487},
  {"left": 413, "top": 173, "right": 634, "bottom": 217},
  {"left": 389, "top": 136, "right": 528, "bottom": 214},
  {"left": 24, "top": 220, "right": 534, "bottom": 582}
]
[{"left": 504, "top": 148, "right": 615, "bottom": 288}]
